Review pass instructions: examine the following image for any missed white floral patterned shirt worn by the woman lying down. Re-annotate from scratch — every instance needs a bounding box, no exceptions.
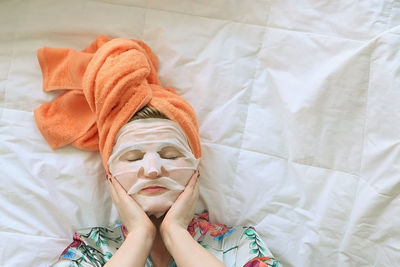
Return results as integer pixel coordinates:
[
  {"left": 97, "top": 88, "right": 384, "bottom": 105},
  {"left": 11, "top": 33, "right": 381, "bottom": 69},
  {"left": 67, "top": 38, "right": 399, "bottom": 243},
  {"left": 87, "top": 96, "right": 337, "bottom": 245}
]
[{"left": 51, "top": 212, "right": 281, "bottom": 267}]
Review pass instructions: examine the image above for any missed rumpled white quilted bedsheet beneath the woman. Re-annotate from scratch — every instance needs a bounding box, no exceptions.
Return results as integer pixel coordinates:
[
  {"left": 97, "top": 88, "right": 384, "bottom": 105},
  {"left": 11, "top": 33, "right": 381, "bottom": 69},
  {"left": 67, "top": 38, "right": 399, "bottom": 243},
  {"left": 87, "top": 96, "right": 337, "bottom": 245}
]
[{"left": 0, "top": 0, "right": 400, "bottom": 267}]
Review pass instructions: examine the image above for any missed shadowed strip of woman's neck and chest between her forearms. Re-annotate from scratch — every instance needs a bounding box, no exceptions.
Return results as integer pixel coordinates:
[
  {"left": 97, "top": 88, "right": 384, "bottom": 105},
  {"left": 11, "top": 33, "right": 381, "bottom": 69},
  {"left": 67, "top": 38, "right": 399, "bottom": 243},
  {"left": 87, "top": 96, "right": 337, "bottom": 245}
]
[{"left": 150, "top": 216, "right": 171, "bottom": 267}]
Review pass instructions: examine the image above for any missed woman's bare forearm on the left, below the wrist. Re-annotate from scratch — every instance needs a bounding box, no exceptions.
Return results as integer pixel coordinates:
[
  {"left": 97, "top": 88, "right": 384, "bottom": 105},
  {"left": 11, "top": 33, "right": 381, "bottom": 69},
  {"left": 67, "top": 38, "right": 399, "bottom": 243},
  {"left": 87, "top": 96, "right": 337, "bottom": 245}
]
[{"left": 104, "top": 231, "right": 154, "bottom": 267}]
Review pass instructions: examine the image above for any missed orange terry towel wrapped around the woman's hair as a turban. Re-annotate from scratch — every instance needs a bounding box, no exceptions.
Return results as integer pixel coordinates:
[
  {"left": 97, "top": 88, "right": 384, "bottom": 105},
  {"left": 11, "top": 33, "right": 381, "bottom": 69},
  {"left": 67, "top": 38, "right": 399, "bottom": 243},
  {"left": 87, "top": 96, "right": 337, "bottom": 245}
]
[{"left": 34, "top": 35, "right": 201, "bottom": 173}]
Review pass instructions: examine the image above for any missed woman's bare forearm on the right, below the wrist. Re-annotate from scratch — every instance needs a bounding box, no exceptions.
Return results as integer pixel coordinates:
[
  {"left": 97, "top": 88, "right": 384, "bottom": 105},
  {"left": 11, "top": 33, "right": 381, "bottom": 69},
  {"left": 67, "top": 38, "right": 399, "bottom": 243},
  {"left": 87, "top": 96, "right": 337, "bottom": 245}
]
[{"left": 163, "top": 228, "right": 225, "bottom": 267}]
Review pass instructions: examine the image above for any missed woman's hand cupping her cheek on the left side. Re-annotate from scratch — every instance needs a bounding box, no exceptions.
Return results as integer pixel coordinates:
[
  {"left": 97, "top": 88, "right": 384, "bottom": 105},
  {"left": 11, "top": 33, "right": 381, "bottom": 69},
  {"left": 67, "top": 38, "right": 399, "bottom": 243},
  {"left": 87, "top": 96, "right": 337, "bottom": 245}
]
[{"left": 107, "top": 176, "right": 156, "bottom": 242}]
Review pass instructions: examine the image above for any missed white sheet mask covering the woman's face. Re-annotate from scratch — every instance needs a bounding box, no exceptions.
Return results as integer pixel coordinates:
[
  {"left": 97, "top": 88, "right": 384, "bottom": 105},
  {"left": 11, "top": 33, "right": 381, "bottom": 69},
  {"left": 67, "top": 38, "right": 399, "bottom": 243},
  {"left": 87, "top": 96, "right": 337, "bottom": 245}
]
[{"left": 108, "top": 118, "right": 199, "bottom": 217}]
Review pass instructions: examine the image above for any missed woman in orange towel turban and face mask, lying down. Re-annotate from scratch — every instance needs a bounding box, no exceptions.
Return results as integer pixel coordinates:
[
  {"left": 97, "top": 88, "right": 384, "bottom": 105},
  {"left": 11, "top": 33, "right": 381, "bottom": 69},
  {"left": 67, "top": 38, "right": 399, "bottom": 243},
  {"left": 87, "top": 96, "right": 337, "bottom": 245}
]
[{"left": 35, "top": 36, "right": 279, "bottom": 267}]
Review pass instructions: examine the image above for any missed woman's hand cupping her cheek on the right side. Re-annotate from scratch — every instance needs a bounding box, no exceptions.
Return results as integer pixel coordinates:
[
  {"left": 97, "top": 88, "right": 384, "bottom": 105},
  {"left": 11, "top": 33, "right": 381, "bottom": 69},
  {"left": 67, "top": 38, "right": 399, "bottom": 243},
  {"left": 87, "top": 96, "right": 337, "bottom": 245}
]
[{"left": 160, "top": 170, "right": 200, "bottom": 235}]
